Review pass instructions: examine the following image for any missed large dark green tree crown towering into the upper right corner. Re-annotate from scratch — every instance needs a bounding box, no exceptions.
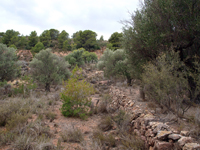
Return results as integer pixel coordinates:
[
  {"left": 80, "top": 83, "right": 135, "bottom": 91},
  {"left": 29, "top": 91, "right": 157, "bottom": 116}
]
[{"left": 123, "top": 0, "right": 200, "bottom": 99}]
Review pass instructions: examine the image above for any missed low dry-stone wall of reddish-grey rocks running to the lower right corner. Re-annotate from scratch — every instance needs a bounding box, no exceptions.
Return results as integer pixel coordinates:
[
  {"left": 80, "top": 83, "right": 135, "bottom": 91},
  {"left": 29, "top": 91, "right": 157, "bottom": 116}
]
[{"left": 109, "top": 85, "right": 200, "bottom": 150}]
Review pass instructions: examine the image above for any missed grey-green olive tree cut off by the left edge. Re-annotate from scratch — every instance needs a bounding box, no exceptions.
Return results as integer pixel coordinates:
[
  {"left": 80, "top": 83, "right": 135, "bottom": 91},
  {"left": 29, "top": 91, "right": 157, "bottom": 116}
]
[{"left": 0, "top": 43, "right": 19, "bottom": 81}]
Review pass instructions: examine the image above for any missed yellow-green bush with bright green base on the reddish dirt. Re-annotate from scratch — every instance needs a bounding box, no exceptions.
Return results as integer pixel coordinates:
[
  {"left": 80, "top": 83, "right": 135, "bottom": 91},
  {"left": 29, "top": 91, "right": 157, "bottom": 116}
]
[{"left": 61, "top": 66, "right": 94, "bottom": 118}]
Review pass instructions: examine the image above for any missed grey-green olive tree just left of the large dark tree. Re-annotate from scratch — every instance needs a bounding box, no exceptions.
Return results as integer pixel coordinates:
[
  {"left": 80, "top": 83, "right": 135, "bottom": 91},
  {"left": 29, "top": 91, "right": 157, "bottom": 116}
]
[{"left": 97, "top": 49, "right": 132, "bottom": 85}]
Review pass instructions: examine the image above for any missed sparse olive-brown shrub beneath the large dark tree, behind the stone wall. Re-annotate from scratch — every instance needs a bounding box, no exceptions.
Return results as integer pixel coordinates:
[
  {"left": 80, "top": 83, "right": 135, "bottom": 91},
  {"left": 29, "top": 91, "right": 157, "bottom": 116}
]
[{"left": 142, "top": 51, "right": 200, "bottom": 115}]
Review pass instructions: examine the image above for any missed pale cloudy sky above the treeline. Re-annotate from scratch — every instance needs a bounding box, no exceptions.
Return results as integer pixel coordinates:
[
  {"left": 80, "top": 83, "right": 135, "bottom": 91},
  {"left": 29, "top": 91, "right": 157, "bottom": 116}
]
[{"left": 0, "top": 0, "right": 140, "bottom": 40}]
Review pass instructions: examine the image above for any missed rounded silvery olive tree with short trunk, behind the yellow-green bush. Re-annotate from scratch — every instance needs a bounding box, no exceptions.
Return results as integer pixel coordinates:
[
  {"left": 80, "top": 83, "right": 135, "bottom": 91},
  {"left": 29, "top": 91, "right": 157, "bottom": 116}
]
[{"left": 30, "top": 49, "right": 70, "bottom": 92}]
